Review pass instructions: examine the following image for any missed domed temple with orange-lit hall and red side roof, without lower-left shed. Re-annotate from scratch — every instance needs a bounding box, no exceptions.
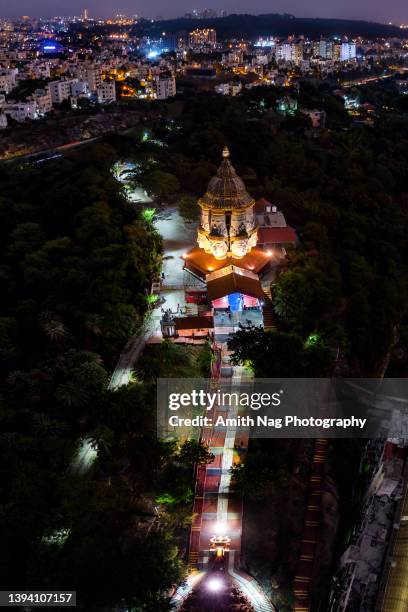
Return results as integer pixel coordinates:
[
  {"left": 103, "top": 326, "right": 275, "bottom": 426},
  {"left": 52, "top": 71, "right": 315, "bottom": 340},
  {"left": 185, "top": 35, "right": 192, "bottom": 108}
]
[{"left": 184, "top": 148, "right": 296, "bottom": 323}]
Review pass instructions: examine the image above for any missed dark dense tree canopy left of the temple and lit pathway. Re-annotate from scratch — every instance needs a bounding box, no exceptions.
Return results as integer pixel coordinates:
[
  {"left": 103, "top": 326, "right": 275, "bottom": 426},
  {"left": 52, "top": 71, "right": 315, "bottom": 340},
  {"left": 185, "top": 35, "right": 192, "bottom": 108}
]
[{"left": 0, "top": 147, "right": 207, "bottom": 610}]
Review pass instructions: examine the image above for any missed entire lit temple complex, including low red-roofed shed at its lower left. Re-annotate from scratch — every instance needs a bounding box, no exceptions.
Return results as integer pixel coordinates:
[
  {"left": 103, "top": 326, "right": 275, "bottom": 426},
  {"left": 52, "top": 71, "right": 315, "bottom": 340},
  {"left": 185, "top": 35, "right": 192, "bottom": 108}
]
[{"left": 162, "top": 148, "right": 296, "bottom": 337}]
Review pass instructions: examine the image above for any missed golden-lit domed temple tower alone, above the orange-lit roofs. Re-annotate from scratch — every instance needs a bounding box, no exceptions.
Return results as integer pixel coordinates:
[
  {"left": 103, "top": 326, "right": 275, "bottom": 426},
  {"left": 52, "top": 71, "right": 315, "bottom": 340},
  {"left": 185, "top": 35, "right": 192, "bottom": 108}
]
[{"left": 198, "top": 148, "right": 257, "bottom": 260}]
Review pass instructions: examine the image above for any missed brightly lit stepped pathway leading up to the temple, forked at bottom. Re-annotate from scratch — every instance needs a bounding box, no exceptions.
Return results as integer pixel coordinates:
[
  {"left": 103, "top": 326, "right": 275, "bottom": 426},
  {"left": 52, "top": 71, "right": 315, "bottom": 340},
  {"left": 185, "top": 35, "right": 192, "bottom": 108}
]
[{"left": 173, "top": 346, "right": 274, "bottom": 612}]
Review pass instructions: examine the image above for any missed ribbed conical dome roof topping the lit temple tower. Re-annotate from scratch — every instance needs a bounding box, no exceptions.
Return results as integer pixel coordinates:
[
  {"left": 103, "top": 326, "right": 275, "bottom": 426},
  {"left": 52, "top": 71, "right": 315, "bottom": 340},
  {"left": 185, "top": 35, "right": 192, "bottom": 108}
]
[{"left": 198, "top": 147, "right": 254, "bottom": 209}]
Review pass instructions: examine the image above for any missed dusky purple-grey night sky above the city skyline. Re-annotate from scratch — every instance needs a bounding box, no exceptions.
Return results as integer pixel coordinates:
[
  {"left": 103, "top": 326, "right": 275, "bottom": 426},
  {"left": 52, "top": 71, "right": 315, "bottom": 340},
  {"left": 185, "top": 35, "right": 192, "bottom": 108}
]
[{"left": 0, "top": 0, "right": 408, "bottom": 24}]
